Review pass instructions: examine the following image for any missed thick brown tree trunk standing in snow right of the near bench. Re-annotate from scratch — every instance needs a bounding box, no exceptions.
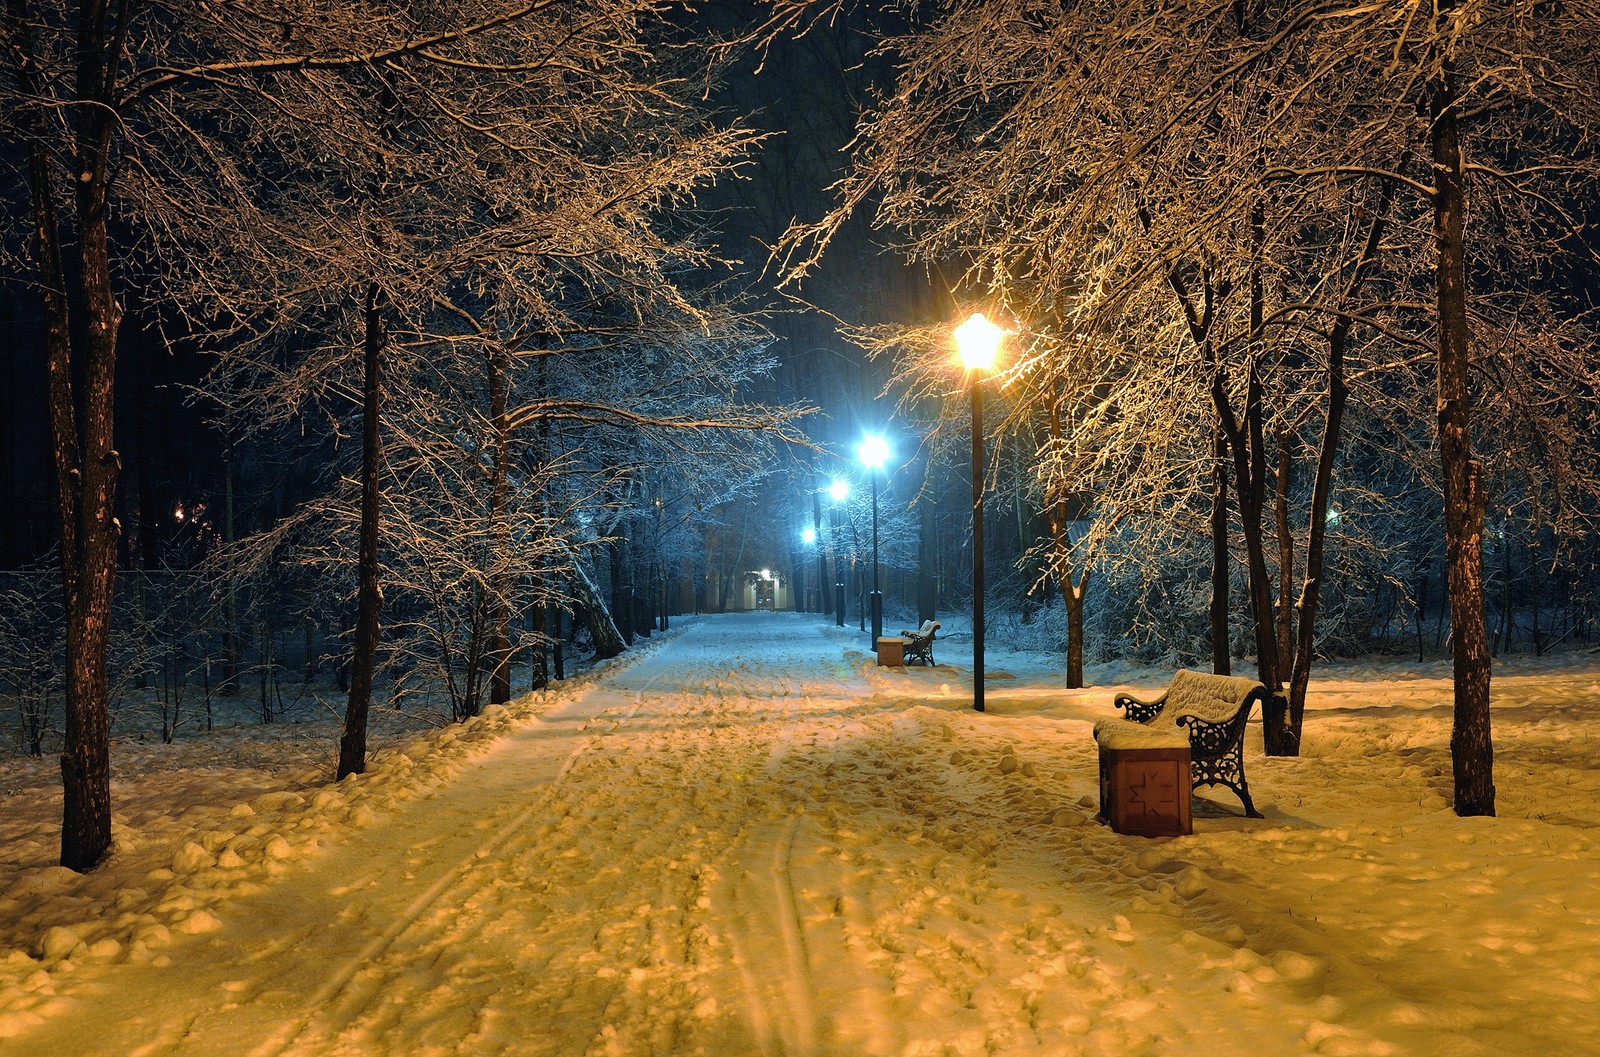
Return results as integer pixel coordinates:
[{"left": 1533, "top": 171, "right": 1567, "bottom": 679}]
[{"left": 1429, "top": 34, "right": 1494, "bottom": 816}]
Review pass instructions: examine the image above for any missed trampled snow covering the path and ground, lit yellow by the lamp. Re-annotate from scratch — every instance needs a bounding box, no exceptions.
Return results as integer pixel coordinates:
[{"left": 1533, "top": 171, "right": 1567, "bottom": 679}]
[{"left": 0, "top": 612, "right": 1600, "bottom": 1057}]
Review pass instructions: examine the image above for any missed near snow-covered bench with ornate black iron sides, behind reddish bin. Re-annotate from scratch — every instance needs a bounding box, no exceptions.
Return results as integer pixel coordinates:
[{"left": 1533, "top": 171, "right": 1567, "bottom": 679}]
[{"left": 1112, "top": 668, "right": 1267, "bottom": 819}]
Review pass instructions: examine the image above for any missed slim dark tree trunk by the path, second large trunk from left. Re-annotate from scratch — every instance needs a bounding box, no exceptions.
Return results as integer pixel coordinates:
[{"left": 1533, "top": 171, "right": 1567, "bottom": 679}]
[{"left": 336, "top": 281, "right": 386, "bottom": 779}]
